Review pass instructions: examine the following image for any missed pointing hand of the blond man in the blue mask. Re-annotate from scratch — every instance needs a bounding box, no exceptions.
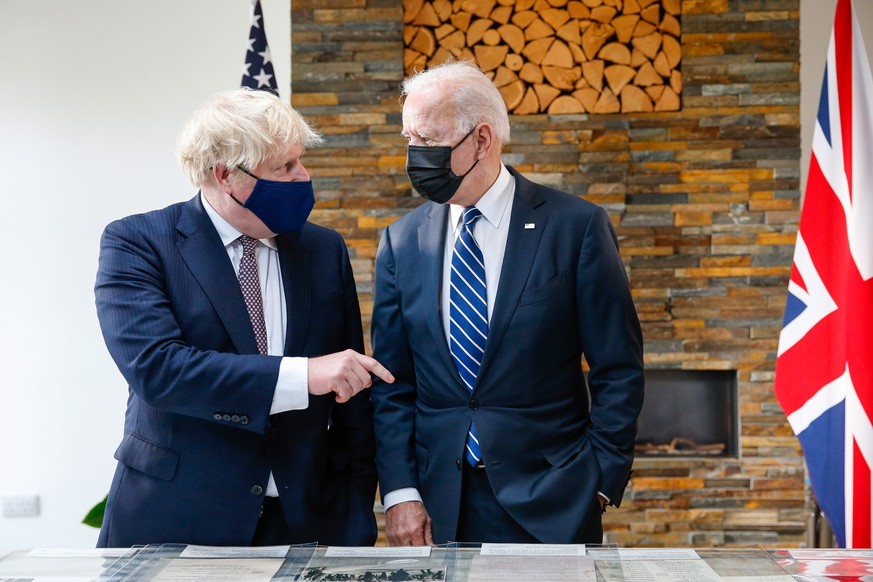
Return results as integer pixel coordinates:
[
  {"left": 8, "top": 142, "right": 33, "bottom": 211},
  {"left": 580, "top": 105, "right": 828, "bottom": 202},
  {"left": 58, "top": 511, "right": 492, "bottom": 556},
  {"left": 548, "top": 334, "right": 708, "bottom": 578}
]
[{"left": 309, "top": 350, "right": 394, "bottom": 404}]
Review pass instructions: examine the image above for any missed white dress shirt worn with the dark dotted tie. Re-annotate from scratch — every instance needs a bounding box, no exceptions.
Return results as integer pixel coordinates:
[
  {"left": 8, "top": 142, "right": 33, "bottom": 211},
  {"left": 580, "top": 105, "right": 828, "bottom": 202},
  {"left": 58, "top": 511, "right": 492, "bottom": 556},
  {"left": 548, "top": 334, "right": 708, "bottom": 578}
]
[{"left": 200, "top": 194, "right": 309, "bottom": 497}]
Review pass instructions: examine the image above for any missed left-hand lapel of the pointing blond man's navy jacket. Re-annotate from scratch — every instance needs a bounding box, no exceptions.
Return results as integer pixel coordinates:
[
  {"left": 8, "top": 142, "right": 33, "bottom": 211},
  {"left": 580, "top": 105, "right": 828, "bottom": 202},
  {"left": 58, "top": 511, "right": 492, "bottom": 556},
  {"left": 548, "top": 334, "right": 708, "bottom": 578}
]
[{"left": 176, "top": 195, "right": 258, "bottom": 354}]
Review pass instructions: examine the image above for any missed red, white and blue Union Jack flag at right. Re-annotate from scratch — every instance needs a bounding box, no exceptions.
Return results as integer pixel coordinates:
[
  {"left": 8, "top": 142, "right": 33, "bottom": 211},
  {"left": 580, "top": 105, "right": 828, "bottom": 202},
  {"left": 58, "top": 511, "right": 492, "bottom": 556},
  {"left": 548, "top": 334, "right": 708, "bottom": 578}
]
[{"left": 775, "top": 0, "right": 873, "bottom": 548}]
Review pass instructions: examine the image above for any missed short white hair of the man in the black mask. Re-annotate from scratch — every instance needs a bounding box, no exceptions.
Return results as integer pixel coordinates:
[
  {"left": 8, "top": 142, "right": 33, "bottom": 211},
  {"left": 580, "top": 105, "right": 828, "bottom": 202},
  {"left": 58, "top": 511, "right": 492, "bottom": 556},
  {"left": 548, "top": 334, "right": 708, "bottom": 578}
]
[{"left": 400, "top": 61, "right": 509, "bottom": 144}]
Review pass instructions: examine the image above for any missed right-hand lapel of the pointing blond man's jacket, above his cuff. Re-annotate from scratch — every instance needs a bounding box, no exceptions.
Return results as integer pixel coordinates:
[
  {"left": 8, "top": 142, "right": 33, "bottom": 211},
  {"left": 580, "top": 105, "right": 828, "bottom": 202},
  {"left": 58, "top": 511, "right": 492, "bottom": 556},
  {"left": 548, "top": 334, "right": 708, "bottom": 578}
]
[{"left": 276, "top": 235, "right": 312, "bottom": 355}]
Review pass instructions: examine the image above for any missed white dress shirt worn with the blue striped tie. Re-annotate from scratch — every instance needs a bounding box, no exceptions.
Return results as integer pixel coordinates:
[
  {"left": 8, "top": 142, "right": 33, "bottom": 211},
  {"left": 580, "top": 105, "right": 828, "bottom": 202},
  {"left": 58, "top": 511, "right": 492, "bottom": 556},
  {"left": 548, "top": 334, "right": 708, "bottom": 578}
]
[{"left": 383, "top": 165, "right": 515, "bottom": 509}]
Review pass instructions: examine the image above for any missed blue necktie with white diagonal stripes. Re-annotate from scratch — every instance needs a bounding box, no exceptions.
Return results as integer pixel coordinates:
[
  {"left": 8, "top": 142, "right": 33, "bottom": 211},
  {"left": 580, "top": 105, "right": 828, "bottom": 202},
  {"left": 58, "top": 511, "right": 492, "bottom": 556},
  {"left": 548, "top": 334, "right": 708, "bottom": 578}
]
[{"left": 449, "top": 206, "right": 488, "bottom": 466}]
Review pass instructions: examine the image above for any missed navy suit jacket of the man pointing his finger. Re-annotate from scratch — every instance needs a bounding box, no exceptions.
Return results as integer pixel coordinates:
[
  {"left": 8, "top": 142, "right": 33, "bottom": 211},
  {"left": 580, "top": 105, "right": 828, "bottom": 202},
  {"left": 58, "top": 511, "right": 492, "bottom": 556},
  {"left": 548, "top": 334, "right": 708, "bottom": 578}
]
[{"left": 95, "top": 196, "right": 376, "bottom": 547}]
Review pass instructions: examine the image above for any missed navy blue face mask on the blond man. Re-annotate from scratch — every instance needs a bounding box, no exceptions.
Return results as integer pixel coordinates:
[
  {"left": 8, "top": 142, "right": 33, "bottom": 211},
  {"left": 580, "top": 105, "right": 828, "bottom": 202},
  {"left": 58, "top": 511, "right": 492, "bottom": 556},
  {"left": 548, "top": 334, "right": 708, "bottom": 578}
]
[{"left": 230, "top": 168, "right": 315, "bottom": 234}]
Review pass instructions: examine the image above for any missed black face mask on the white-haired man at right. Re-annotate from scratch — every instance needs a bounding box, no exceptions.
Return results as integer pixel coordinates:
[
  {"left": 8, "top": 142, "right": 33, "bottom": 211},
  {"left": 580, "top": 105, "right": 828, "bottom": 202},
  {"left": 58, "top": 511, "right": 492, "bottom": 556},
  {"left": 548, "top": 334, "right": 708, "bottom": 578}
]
[{"left": 406, "top": 125, "right": 479, "bottom": 204}]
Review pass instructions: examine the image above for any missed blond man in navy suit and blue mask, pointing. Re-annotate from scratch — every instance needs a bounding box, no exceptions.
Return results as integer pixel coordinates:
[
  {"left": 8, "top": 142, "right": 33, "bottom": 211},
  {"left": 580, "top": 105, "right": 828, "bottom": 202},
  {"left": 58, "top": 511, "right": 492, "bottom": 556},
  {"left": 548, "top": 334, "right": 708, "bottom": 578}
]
[{"left": 95, "top": 89, "right": 393, "bottom": 547}]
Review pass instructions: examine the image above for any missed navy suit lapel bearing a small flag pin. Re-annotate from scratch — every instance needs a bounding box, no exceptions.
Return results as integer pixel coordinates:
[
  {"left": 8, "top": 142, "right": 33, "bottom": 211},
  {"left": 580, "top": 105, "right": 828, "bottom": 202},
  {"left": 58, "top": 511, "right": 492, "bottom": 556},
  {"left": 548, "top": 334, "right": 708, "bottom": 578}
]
[{"left": 477, "top": 168, "right": 548, "bottom": 386}]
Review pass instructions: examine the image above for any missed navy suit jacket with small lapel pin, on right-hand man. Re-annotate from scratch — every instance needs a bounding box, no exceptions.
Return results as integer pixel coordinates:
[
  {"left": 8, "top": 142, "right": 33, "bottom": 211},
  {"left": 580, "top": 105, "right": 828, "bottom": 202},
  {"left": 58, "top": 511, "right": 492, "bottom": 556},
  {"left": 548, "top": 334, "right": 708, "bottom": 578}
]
[{"left": 372, "top": 169, "right": 643, "bottom": 543}]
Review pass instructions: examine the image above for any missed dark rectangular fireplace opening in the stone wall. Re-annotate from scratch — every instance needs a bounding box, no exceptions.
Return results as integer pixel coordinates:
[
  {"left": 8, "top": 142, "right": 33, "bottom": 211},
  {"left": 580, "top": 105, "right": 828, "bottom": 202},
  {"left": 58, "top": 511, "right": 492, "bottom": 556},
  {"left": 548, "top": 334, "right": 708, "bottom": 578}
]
[{"left": 634, "top": 370, "right": 739, "bottom": 457}]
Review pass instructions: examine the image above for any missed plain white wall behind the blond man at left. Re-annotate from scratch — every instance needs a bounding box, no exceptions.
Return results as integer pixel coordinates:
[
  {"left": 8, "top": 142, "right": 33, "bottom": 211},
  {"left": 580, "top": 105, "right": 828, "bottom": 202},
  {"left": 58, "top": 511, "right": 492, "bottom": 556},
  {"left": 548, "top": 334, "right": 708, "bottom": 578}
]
[{"left": 0, "top": 0, "right": 291, "bottom": 555}]
